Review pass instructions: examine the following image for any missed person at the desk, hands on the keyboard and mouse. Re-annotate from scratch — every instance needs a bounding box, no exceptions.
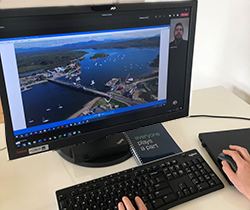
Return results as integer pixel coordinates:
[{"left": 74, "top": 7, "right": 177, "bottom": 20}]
[{"left": 118, "top": 145, "right": 250, "bottom": 210}]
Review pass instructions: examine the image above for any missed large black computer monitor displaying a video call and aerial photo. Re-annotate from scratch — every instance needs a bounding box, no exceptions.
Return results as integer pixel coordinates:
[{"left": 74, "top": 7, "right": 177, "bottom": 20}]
[{"left": 0, "top": 0, "right": 197, "bottom": 165}]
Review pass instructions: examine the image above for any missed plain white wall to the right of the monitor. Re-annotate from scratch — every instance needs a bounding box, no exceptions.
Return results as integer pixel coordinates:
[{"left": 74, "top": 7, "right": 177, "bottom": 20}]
[{"left": 146, "top": 0, "right": 250, "bottom": 103}]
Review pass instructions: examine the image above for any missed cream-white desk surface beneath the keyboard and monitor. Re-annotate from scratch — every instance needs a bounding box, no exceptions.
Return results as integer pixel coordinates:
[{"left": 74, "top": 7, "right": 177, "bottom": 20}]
[{"left": 0, "top": 87, "right": 250, "bottom": 210}]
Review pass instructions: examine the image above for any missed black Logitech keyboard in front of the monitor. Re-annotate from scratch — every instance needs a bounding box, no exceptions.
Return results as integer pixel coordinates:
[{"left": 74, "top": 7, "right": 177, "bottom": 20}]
[{"left": 56, "top": 149, "right": 224, "bottom": 210}]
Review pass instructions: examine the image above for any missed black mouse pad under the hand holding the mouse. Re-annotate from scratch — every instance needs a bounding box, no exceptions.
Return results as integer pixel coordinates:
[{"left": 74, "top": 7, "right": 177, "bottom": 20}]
[{"left": 199, "top": 128, "right": 250, "bottom": 185}]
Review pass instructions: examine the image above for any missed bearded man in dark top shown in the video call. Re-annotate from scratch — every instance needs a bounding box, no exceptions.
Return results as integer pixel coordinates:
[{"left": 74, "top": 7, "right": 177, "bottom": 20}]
[{"left": 170, "top": 22, "right": 187, "bottom": 49}]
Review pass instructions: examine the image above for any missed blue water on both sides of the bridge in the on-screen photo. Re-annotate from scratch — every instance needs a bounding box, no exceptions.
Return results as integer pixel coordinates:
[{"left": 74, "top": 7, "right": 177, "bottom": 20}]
[{"left": 22, "top": 48, "right": 159, "bottom": 127}]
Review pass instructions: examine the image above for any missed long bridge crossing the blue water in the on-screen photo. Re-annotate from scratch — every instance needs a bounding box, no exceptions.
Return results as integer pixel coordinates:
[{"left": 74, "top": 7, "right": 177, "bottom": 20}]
[{"left": 48, "top": 79, "right": 112, "bottom": 98}]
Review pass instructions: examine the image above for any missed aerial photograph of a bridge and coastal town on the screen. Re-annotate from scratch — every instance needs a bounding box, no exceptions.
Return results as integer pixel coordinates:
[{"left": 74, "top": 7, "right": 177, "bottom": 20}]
[{"left": 15, "top": 30, "right": 160, "bottom": 127}]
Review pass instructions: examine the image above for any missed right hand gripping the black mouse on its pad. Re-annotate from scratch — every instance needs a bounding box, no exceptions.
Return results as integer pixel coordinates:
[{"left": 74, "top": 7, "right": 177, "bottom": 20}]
[{"left": 222, "top": 145, "right": 250, "bottom": 200}]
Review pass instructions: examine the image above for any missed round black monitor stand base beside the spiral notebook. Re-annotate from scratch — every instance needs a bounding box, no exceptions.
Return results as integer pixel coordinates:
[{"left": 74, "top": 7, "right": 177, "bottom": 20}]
[{"left": 57, "top": 133, "right": 131, "bottom": 167}]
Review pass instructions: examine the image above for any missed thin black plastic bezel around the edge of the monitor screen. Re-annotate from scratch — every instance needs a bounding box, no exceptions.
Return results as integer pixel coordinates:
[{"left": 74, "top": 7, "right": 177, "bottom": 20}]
[{"left": 0, "top": 0, "right": 197, "bottom": 160}]
